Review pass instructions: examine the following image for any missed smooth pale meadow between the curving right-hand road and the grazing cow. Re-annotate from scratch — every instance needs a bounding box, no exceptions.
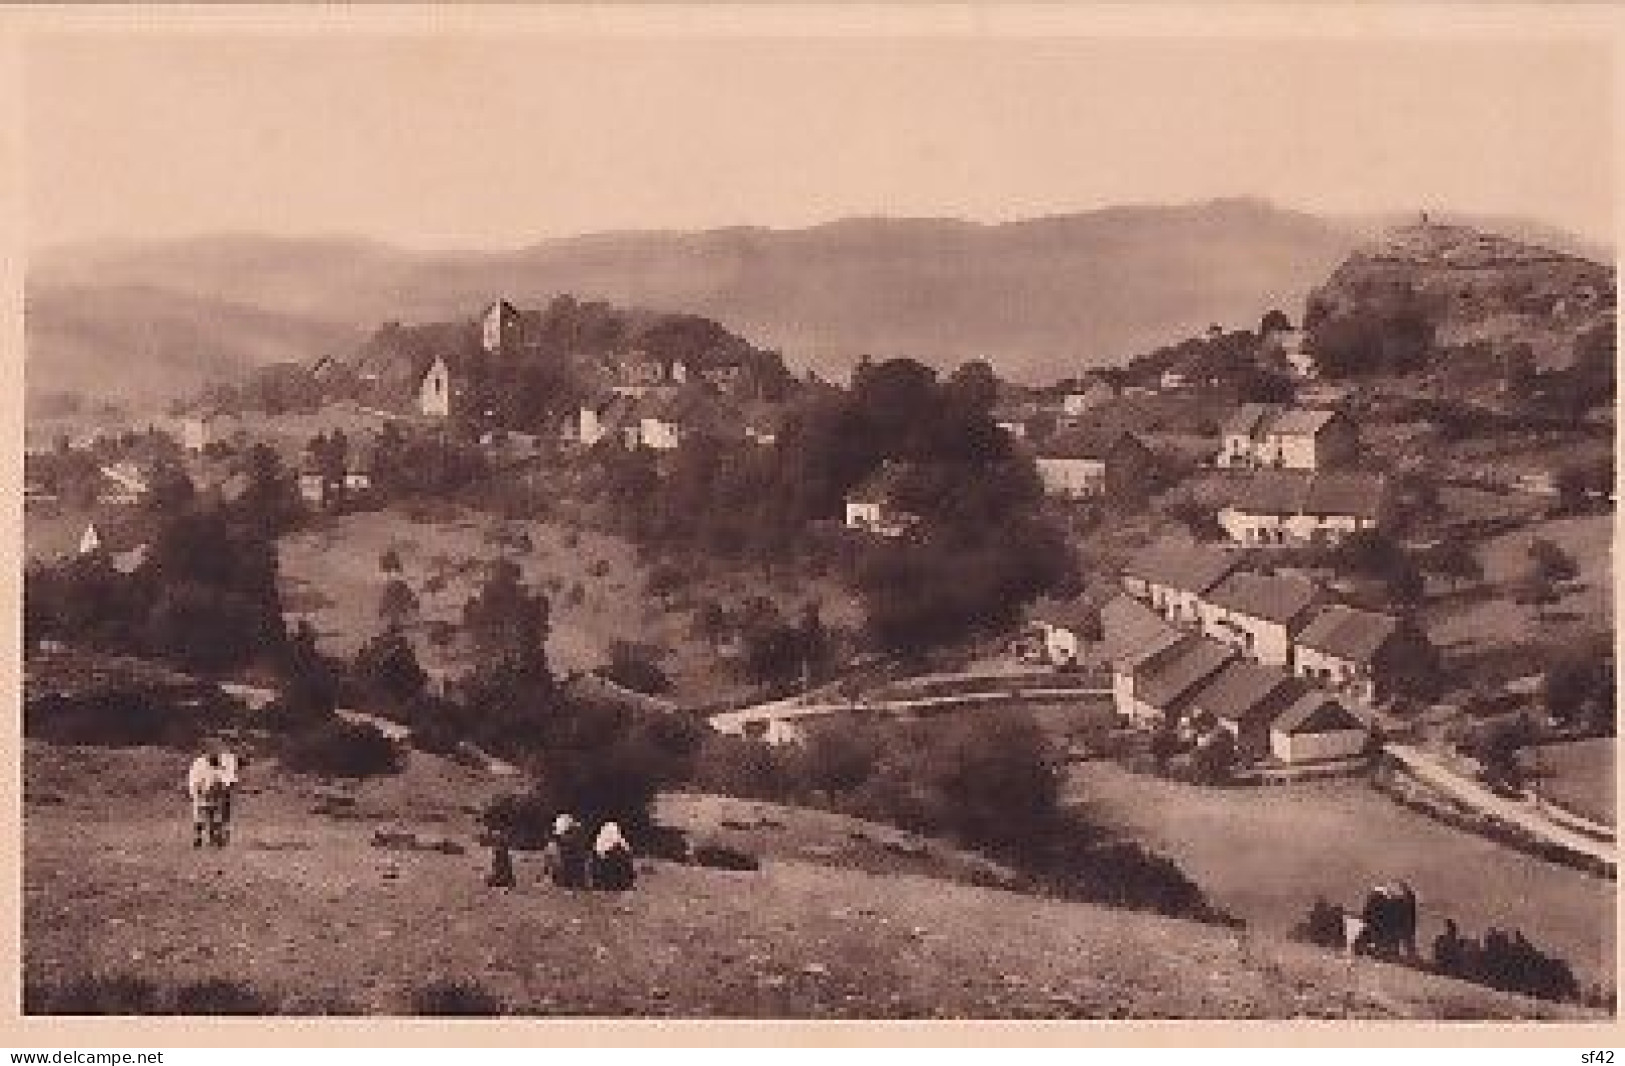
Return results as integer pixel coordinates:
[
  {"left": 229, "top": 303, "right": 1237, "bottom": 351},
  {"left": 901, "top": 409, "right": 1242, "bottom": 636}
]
[{"left": 1071, "top": 762, "right": 1615, "bottom": 982}]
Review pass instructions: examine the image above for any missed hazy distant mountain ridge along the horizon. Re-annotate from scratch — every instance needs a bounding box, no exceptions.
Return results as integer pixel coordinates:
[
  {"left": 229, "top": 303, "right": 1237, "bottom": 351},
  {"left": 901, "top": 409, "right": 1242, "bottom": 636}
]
[{"left": 28, "top": 198, "right": 1612, "bottom": 412}]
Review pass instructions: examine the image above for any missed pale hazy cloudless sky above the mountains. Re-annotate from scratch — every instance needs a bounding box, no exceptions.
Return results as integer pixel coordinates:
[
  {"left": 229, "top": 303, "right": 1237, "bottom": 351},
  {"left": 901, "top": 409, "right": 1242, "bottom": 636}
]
[{"left": 26, "top": 33, "right": 1614, "bottom": 247}]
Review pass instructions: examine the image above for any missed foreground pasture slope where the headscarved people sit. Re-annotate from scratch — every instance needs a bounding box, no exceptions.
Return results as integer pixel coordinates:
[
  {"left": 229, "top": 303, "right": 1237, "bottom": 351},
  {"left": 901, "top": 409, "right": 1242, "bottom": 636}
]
[{"left": 23, "top": 744, "right": 1591, "bottom": 1019}]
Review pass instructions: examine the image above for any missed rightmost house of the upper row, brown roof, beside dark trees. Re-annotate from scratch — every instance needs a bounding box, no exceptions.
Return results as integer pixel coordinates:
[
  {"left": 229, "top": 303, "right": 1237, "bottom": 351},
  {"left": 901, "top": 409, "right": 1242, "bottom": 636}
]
[{"left": 1294, "top": 605, "right": 1432, "bottom": 707}]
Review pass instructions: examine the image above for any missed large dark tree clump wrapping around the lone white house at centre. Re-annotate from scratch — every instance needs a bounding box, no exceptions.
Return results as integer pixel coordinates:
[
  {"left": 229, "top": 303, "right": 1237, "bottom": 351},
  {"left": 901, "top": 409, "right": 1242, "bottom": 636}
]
[{"left": 603, "top": 359, "right": 1073, "bottom": 658}]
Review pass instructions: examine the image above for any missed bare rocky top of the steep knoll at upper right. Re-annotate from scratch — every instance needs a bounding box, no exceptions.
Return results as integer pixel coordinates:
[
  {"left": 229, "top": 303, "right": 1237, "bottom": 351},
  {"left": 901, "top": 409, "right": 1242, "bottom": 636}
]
[{"left": 1307, "top": 221, "right": 1615, "bottom": 371}]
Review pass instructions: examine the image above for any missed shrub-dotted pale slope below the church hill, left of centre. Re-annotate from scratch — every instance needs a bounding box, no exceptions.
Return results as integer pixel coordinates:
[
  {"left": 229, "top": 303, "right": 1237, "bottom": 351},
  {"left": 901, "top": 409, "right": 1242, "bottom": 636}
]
[{"left": 280, "top": 510, "right": 856, "bottom": 699}]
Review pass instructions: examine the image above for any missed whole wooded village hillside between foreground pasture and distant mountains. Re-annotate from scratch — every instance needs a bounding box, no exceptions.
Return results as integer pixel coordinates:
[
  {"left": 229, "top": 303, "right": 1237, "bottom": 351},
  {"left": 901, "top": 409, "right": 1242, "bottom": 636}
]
[{"left": 26, "top": 219, "right": 1615, "bottom": 1003}]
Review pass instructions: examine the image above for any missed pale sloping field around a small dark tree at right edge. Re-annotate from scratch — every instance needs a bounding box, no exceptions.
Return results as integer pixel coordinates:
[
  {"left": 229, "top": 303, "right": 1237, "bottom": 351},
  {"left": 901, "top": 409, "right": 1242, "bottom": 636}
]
[{"left": 1428, "top": 515, "right": 1614, "bottom": 663}]
